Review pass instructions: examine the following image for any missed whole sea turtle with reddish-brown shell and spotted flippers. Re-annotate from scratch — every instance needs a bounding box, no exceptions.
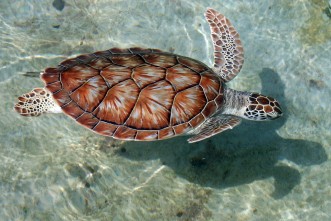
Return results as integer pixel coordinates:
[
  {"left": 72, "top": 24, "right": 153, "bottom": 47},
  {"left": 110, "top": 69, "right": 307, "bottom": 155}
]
[{"left": 15, "top": 8, "right": 282, "bottom": 143}]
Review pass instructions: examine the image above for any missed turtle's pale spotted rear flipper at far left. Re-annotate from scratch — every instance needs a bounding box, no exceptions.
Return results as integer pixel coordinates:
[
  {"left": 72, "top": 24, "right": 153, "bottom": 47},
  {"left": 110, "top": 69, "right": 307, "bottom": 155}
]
[{"left": 14, "top": 88, "right": 62, "bottom": 116}]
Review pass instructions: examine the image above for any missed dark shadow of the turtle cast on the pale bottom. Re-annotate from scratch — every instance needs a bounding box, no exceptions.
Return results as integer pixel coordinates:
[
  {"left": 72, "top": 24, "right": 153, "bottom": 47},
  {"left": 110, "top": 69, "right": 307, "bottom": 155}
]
[{"left": 119, "top": 68, "right": 327, "bottom": 198}]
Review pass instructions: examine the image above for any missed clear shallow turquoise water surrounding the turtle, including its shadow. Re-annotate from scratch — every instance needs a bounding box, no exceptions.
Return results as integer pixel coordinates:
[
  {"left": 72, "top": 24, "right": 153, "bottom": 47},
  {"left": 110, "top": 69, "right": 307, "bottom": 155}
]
[{"left": 0, "top": 0, "right": 331, "bottom": 221}]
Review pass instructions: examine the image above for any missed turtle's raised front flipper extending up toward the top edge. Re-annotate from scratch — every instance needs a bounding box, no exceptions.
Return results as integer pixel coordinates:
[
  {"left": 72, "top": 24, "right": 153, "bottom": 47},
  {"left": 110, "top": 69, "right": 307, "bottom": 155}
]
[{"left": 205, "top": 8, "right": 244, "bottom": 82}]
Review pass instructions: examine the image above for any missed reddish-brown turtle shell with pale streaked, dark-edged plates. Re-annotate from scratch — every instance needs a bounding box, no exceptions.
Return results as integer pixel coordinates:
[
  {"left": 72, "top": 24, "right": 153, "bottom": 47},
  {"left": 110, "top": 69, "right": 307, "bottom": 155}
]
[{"left": 41, "top": 48, "right": 223, "bottom": 141}]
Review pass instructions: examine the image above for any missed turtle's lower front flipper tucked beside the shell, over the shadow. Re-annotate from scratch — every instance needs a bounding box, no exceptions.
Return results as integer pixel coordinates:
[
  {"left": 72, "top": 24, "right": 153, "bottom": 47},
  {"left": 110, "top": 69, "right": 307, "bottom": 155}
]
[{"left": 187, "top": 115, "right": 241, "bottom": 143}]
